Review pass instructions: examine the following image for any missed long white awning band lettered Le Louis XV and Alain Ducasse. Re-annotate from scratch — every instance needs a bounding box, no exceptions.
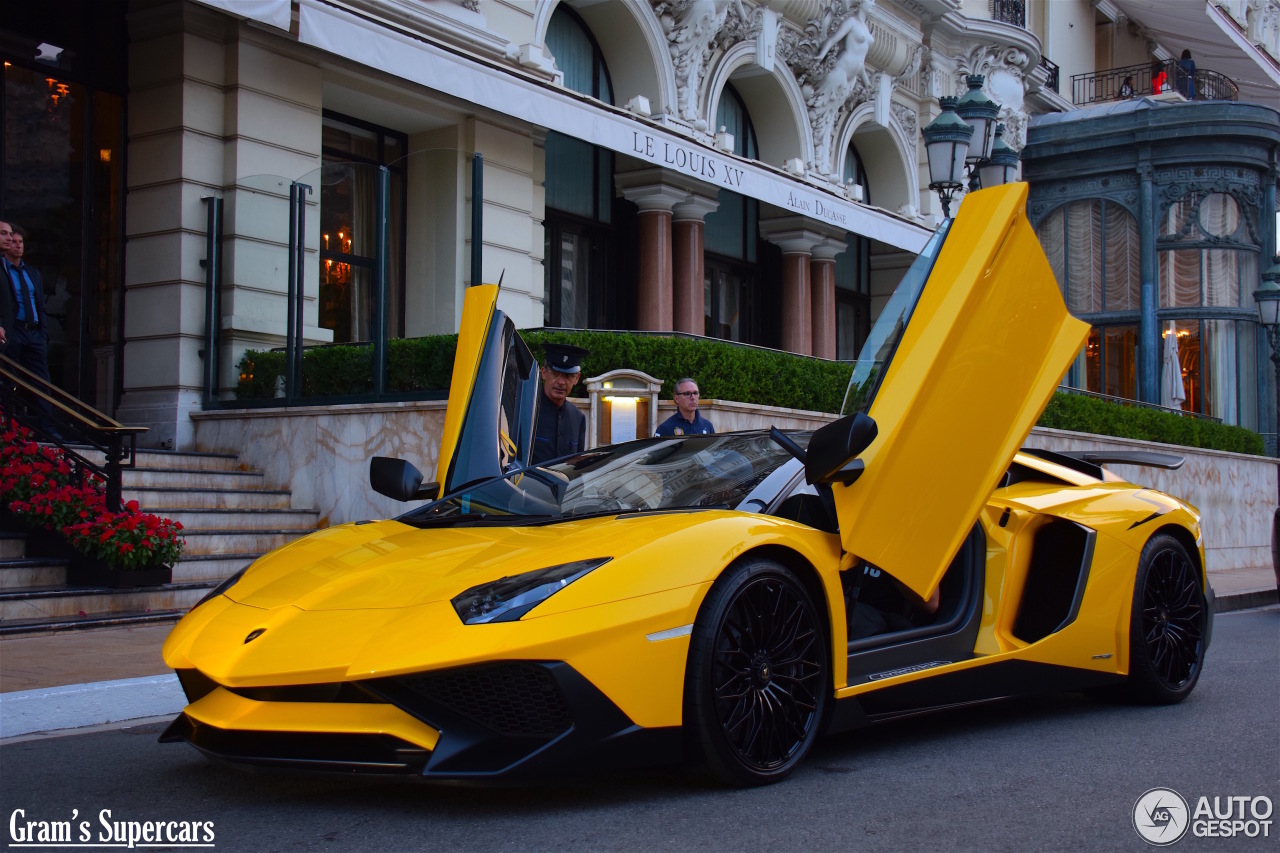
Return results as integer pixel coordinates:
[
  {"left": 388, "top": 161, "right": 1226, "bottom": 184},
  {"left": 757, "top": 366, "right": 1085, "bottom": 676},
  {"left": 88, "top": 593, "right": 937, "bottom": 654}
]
[{"left": 298, "top": 0, "right": 932, "bottom": 252}]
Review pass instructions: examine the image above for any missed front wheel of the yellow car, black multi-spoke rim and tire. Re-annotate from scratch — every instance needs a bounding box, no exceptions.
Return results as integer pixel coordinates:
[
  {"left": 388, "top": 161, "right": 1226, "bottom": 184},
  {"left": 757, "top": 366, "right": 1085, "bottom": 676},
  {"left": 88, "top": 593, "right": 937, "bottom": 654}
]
[{"left": 685, "top": 558, "right": 832, "bottom": 786}]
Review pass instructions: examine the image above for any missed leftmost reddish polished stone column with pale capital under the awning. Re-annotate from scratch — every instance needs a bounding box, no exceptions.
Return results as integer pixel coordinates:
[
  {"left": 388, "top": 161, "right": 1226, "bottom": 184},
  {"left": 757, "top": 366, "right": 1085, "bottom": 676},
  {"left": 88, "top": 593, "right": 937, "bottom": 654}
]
[{"left": 614, "top": 169, "right": 689, "bottom": 332}]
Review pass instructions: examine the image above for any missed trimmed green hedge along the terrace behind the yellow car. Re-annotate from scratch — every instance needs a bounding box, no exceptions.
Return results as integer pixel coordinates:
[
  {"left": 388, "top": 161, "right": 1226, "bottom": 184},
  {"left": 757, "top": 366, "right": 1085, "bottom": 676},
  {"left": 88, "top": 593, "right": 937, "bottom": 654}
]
[{"left": 237, "top": 330, "right": 1263, "bottom": 456}]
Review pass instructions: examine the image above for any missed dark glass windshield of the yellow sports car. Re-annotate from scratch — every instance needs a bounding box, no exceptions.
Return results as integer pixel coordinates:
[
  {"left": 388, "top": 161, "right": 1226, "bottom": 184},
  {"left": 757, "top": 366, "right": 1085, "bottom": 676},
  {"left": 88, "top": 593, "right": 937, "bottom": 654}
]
[{"left": 399, "top": 433, "right": 809, "bottom": 525}]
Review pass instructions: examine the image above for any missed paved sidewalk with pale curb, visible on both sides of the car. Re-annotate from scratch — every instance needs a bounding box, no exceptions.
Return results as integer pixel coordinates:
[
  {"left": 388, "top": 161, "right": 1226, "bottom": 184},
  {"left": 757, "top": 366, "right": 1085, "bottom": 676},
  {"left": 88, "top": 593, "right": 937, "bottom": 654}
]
[{"left": 0, "top": 566, "right": 1277, "bottom": 739}]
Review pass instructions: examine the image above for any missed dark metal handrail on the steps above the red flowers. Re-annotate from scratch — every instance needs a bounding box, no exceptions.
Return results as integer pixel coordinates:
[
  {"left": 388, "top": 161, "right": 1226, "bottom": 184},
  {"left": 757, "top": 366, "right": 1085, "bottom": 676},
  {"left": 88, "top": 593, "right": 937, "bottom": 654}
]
[{"left": 0, "top": 355, "right": 147, "bottom": 512}]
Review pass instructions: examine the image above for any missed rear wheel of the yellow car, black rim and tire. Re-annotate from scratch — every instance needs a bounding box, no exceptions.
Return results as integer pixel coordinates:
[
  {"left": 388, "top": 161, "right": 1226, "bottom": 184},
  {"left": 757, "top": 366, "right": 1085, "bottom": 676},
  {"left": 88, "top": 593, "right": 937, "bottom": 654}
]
[{"left": 1121, "top": 533, "right": 1208, "bottom": 704}]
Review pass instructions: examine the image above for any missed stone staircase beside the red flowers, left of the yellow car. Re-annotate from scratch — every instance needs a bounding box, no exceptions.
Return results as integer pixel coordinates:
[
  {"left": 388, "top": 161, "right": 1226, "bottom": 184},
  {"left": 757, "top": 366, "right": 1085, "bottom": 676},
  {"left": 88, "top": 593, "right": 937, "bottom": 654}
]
[{"left": 0, "top": 451, "right": 319, "bottom": 635}]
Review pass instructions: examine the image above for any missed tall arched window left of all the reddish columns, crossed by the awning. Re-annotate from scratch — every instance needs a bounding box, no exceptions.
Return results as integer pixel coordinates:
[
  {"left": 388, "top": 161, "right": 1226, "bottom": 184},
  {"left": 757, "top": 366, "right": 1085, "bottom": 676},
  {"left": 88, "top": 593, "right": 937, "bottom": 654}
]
[{"left": 543, "top": 3, "right": 613, "bottom": 328}]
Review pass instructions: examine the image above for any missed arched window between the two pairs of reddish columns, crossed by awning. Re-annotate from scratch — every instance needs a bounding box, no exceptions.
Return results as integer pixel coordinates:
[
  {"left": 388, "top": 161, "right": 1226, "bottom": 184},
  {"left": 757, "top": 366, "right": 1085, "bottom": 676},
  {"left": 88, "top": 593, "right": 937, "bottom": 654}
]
[{"left": 703, "top": 85, "right": 762, "bottom": 343}]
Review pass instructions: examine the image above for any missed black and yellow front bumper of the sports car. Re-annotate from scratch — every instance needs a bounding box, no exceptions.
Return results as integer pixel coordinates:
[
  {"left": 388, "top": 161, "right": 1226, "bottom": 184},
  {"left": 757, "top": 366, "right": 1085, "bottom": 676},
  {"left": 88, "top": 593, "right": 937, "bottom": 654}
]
[{"left": 160, "top": 661, "right": 681, "bottom": 779}]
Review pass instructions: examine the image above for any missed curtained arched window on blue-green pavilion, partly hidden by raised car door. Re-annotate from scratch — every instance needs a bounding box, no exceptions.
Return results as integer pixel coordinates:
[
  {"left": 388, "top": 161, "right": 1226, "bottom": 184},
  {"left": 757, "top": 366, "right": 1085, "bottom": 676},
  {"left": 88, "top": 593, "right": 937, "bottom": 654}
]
[{"left": 1037, "top": 199, "right": 1142, "bottom": 400}]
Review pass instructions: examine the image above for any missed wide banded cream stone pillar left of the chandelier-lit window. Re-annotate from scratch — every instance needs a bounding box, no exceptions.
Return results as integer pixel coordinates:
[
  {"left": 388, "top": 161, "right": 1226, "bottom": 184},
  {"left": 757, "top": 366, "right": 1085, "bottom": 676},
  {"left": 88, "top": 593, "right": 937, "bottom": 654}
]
[{"left": 116, "top": 3, "right": 321, "bottom": 450}]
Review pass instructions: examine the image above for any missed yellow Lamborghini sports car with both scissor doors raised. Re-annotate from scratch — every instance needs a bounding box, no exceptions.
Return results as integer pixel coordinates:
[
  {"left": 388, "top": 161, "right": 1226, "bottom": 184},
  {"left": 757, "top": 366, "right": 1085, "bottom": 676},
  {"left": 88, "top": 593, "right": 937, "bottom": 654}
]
[{"left": 161, "top": 184, "right": 1212, "bottom": 785}]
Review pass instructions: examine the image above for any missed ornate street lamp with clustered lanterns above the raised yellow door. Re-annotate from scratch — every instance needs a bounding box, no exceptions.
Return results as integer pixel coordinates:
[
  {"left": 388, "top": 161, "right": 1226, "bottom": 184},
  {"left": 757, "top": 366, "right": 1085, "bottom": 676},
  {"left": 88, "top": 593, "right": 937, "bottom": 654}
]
[{"left": 920, "top": 74, "right": 1019, "bottom": 216}]
